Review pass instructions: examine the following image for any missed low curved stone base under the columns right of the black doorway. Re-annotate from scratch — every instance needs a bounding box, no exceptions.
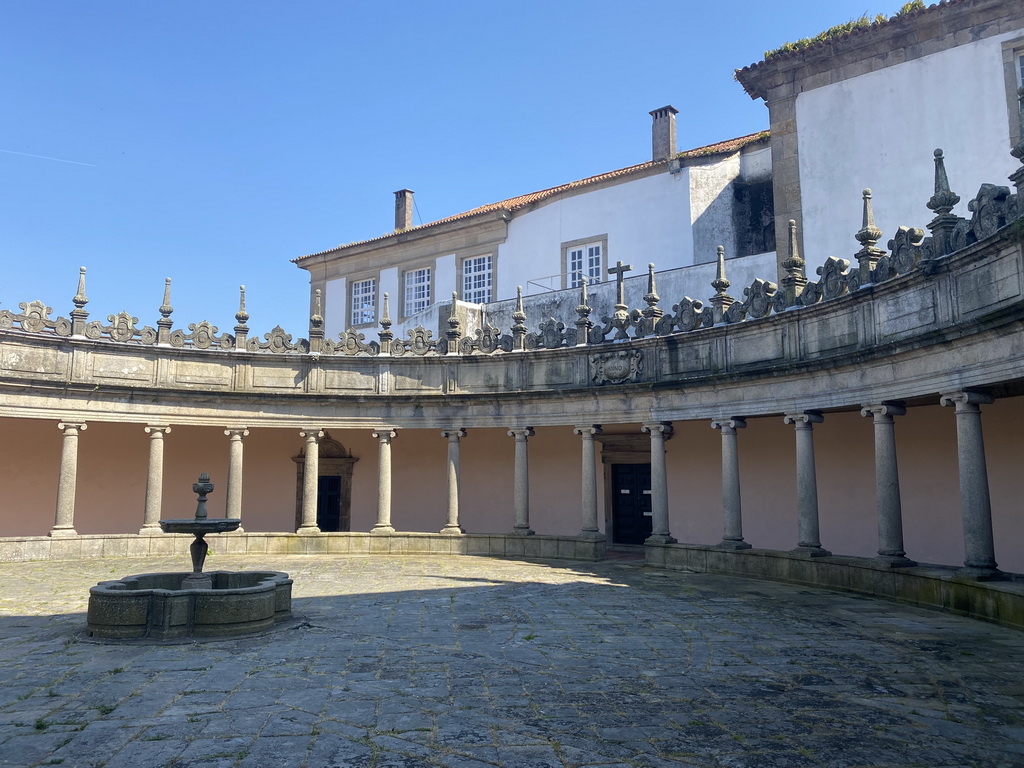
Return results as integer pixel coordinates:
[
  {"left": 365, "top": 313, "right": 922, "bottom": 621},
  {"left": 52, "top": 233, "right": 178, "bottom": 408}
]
[{"left": 644, "top": 544, "right": 1024, "bottom": 630}]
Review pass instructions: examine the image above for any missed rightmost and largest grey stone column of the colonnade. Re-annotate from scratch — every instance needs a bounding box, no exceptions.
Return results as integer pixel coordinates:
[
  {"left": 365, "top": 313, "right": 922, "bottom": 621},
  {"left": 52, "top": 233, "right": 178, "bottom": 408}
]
[{"left": 940, "top": 392, "right": 1002, "bottom": 580}]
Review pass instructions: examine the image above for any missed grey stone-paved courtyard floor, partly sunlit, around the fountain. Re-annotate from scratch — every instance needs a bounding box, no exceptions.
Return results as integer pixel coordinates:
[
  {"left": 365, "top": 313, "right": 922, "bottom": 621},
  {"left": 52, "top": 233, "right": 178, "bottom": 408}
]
[{"left": 0, "top": 556, "right": 1024, "bottom": 768}]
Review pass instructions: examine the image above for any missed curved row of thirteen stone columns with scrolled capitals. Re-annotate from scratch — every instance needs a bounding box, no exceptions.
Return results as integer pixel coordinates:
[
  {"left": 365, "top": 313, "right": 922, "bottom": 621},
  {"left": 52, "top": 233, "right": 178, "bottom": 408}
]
[{"left": 50, "top": 391, "right": 999, "bottom": 579}]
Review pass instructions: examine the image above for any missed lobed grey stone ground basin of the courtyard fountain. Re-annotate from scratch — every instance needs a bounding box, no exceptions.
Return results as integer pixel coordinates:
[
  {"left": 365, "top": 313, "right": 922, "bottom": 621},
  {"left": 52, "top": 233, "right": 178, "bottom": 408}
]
[{"left": 86, "top": 570, "right": 292, "bottom": 640}]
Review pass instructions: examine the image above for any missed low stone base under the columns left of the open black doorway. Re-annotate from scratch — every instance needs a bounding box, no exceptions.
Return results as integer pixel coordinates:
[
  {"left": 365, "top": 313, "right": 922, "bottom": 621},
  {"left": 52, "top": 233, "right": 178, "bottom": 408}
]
[{"left": 0, "top": 531, "right": 605, "bottom": 562}]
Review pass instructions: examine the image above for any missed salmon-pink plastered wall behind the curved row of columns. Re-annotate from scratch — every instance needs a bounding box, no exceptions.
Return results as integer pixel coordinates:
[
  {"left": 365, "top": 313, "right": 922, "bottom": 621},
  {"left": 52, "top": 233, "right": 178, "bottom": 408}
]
[{"left": 0, "top": 397, "right": 1024, "bottom": 572}]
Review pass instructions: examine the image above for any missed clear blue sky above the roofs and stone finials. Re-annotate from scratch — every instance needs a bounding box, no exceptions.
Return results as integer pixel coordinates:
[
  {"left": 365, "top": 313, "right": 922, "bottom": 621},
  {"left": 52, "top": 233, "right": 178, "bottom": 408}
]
[{"left": 0, "top": 0, "right": 902, "bottom": 336}]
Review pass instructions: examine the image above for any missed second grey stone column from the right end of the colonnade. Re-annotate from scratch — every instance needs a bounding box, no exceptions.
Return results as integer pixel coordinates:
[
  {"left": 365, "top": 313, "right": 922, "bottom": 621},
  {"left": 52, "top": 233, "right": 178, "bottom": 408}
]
[{"left": 860, "top": 402, "right": 916, "bottom": 568}]
